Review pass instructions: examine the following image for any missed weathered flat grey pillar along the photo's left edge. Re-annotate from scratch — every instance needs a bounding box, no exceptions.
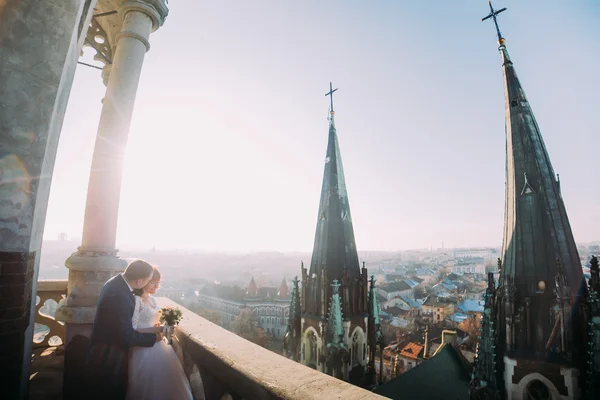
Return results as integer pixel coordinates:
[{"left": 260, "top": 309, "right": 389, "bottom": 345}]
[{"left": 0, "top": 0, "right": 95, "bottom": 399}]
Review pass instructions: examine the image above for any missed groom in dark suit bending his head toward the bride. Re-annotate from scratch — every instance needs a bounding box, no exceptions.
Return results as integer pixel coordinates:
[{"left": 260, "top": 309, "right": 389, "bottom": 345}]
[{"left": 85, "top": 260, "right": 162, "bottom": 400}]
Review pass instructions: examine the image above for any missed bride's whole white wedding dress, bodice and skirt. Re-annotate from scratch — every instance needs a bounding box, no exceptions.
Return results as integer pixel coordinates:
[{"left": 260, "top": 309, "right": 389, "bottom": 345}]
[{"left": 127, "top": 296, "right": 193, "bottom": 400}]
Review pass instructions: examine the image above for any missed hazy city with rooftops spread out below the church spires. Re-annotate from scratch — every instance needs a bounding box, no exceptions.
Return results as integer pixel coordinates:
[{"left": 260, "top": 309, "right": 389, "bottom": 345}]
[{"left": 38, "top": 238, "right": 600, "bottom": 382}]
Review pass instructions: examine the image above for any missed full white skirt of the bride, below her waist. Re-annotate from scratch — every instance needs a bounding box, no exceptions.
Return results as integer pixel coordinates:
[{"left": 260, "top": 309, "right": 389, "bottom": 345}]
[{"left": 127, "top": 341, "right": 193, "bottom": 400}]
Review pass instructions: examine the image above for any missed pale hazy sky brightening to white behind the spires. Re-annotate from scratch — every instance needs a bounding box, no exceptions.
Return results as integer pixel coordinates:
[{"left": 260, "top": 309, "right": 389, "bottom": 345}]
[{"left": 44, "top": 0, "right": 600, "bottom": 251}]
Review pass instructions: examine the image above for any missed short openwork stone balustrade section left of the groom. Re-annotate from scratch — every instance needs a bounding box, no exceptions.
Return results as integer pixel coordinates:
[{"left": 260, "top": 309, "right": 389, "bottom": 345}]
[{"left": 33, "top": 279, "right": 67, "bottom": 349}]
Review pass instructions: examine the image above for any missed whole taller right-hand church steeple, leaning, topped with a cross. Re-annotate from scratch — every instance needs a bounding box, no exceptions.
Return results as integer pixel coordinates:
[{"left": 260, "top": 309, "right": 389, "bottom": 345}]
[{"left": 474, "top": 2, "right": 585, "bottom": 398}]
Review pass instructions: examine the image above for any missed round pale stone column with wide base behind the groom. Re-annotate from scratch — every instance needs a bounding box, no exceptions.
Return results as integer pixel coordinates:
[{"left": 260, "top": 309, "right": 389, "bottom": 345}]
[{"left": 56, "top": 0, "right": 168, "bottom": 399}]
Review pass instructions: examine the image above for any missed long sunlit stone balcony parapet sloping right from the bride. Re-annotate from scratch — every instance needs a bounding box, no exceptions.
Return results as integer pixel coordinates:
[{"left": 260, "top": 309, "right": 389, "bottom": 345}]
[{"left": 159, "top": 297, "right": 385, "bottom": 400}]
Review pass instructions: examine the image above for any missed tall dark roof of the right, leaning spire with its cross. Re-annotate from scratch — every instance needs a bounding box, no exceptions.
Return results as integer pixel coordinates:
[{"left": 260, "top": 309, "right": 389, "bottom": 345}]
[{"left": 490, "top": 12, "right": 582, "bottom": 296}]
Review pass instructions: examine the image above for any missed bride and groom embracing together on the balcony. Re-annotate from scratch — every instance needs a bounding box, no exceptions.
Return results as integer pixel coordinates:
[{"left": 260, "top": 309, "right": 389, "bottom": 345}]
[{"left": 85, "top": 260, "right": 203, "bottom": 400}]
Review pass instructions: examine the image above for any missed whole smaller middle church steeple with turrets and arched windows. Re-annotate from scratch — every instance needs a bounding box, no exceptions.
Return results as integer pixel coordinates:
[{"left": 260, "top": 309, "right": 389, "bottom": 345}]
[{"left": 284, "top": 88, "right": 383, "bottom": 386}]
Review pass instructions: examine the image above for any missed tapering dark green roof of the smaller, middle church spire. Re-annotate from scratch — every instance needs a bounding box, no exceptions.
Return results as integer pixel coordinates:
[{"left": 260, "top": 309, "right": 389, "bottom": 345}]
[{"left": 310, "top": 99, "right": 360, "bottom": 284}]
